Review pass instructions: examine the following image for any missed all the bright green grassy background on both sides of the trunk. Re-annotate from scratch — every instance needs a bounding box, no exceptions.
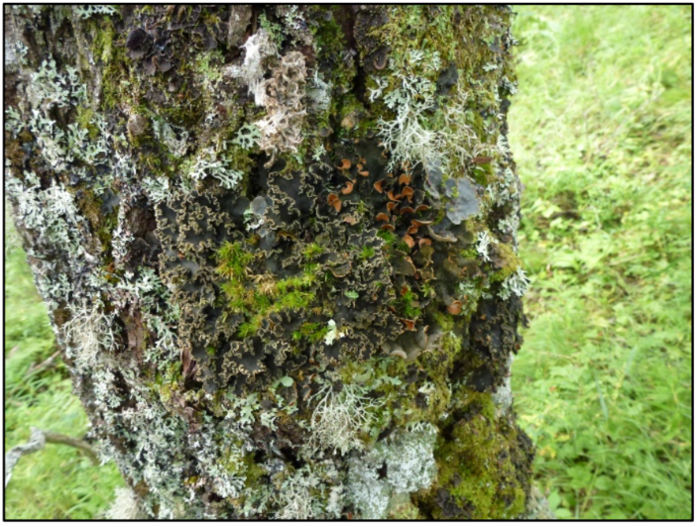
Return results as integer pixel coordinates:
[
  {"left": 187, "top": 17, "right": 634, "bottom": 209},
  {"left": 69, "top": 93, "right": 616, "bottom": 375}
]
[{"left": 5, "top": 6, "right": 692, "bottom": 519}]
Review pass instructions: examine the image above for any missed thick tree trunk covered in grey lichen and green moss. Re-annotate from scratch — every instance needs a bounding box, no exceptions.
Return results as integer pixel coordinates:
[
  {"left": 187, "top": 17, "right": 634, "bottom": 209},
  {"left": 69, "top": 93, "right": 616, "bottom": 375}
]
[{"left": 5, "top": 5, "right": 533, "bottom": 518}]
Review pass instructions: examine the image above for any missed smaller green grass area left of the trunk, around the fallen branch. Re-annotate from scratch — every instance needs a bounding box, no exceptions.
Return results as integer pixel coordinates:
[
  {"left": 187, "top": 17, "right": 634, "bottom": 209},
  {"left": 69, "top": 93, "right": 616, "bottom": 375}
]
[{"left": 5, "top": 243, "right": 123, "bottom": 519}]
